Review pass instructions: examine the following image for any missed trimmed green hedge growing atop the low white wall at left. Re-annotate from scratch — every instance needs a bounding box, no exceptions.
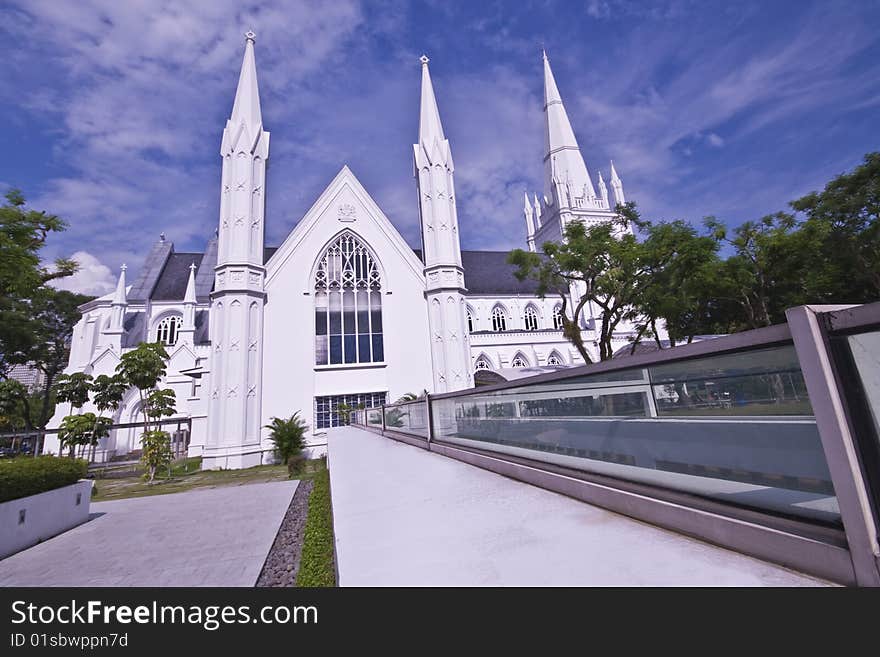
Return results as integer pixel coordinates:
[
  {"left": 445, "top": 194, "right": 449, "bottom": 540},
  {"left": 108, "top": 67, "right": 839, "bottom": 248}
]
[{"left": 0, "top": 456, "right": 89, "bottom": 502}]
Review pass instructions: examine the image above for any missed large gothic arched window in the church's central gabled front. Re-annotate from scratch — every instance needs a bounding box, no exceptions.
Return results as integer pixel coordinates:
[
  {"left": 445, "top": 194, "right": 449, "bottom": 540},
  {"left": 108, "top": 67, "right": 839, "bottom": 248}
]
[{"left": 315, "top": 231, "right": 385, "bottom": 365}]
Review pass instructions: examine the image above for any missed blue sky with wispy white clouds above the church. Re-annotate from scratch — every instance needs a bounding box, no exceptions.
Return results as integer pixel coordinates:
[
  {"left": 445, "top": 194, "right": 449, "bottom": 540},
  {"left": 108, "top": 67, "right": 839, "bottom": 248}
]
[{"left": 0, "top": 0, "right": 880, "bottom": 293}]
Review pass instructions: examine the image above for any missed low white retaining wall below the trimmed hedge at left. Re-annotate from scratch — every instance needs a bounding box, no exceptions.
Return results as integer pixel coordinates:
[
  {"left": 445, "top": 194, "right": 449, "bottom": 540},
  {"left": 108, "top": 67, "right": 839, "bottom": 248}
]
[{"left": 0, "top": 479, "right": 93, "bottom": 559}]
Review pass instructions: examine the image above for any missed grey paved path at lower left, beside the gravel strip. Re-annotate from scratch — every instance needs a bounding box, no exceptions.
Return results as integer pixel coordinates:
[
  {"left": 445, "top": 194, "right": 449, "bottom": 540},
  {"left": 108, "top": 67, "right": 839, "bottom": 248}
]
[{"left": 0, "top": 481, "right": 298, "bottom": 586}]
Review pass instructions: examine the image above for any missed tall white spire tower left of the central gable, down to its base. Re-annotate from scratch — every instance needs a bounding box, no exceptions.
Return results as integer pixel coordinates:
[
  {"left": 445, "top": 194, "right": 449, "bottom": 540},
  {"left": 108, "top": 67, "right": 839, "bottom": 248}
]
[{"left": 205, "top": 32, "right": 269, "bottom": 469}]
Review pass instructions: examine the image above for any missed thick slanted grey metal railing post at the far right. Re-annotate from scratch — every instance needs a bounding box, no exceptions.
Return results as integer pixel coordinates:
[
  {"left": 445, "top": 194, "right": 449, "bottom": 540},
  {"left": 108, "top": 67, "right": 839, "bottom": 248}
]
[{"left": 785, "top": 306, "right": 880, "bottom": 586}]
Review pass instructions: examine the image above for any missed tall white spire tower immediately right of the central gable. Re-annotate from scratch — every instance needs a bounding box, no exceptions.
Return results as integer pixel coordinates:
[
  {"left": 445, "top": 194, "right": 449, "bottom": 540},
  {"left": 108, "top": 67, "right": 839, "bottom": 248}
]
[{"left": 413, "top": 55, "right": 473, "bottom": 392}]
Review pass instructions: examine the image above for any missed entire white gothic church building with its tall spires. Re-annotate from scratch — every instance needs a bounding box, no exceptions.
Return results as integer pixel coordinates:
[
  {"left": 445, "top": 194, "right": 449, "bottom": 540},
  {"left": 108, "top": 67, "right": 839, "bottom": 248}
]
[{"left": 45, "top": 32, "right": 633, "bottom": 468}]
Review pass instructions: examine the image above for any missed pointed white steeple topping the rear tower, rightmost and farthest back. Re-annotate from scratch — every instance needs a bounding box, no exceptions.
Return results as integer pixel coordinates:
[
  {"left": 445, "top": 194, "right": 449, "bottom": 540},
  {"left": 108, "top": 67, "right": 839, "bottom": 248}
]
[{"left": 543, "top": 52, "right": 596, "bottom": 207}]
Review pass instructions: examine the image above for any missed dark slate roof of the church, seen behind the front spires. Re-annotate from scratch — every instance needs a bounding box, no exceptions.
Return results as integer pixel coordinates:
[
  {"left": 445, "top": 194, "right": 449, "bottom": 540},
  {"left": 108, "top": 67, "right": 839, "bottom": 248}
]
[{"left": 145, "top": 245, "right": 535, "bottom": 302}]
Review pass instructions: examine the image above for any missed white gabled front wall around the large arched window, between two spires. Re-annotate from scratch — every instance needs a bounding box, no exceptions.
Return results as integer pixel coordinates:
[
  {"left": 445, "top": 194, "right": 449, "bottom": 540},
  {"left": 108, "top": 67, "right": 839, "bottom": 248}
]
[{"left": 263, "top": 167, "right": 432, "bottom": 446}]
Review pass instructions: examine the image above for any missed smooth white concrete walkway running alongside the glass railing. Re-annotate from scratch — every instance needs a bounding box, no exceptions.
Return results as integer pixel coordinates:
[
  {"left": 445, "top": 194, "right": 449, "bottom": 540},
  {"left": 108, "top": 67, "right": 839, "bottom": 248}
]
[{"left": 329, "top": 427, "right": 827, "bottom": 586}]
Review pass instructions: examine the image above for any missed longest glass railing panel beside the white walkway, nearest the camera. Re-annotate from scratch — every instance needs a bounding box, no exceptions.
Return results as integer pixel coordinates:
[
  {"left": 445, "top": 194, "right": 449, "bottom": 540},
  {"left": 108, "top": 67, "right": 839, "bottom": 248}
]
[{"left": 433, "top": 346, "right": 844, "bottom": 524}]
